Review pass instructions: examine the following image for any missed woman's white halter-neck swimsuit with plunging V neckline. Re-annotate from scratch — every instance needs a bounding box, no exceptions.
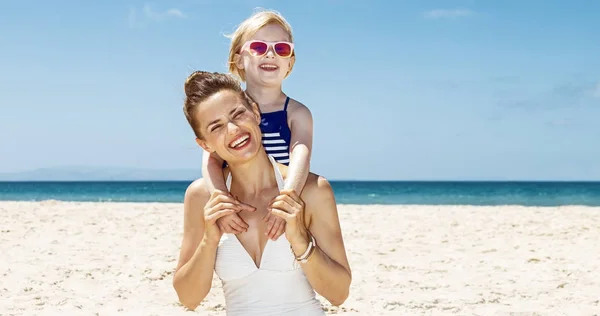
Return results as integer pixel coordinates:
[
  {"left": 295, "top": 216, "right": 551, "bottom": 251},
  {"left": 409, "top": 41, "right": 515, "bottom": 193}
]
[{"left": 215, "top": 156, "right": 325, "bottom": 316}]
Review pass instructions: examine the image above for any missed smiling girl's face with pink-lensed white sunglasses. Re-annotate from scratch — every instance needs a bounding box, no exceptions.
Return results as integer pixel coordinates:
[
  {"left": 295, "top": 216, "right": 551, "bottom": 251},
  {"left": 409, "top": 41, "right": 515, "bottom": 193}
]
[{"left": 236, "top": 23, "right": 295, "bottom": 86}]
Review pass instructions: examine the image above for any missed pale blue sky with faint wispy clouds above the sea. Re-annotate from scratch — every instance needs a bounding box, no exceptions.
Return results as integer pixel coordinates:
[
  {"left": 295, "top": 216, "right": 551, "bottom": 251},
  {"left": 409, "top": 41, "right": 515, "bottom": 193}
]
[{"left": 0, "top": 0, "right": 600, "bottom": 180}]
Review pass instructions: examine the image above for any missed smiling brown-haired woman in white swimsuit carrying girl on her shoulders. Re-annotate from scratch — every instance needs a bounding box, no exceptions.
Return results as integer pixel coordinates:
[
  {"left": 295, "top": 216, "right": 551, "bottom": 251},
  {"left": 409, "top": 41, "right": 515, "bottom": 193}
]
[{"left": 173, "top": 72, "right": 352, "bottom": 316}]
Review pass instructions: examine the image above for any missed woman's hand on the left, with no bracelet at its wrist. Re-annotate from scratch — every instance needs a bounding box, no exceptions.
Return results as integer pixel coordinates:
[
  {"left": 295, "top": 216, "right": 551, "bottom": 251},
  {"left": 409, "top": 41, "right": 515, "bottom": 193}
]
[{"left": 204, "top": 190, "right": 242, "bottom": 243}]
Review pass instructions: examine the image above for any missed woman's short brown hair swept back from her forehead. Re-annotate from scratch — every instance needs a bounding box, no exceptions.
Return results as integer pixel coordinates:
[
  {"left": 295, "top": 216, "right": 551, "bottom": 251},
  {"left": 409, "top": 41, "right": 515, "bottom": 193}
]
[{"left": 183, "top": 71, "right": 254, "bottom": 139}]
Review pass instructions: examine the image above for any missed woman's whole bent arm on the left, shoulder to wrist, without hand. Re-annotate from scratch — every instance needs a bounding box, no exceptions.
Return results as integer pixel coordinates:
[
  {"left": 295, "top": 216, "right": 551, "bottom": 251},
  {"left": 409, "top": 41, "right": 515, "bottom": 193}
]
[{"left": 173, "top": 180, "right": 219, "bottom": 310}]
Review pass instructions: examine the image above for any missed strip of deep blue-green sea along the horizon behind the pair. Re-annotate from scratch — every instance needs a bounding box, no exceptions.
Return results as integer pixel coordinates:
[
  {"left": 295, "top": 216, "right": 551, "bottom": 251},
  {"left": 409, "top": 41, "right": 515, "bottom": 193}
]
[{"left": 0, "top": 181, "right": 600, "bottom": 206}]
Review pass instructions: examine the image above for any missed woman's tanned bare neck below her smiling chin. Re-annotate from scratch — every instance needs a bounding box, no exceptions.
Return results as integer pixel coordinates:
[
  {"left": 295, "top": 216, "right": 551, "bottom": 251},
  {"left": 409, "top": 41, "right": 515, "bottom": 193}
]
[{"left": 229, "top": 148, "right": 277, "bottom": 196}]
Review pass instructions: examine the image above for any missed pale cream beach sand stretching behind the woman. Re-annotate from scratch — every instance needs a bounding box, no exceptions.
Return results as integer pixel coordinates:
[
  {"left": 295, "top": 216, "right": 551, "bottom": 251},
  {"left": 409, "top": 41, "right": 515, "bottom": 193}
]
[{"left": 0, "top": 201, "right": 600, "bottom": 315}]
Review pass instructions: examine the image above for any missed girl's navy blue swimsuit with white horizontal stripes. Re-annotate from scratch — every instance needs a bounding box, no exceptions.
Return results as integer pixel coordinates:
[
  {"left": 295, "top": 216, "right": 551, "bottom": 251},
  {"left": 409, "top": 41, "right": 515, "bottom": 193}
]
[{"left": 260, "top": 97, "right": 292, "bottom": 166}]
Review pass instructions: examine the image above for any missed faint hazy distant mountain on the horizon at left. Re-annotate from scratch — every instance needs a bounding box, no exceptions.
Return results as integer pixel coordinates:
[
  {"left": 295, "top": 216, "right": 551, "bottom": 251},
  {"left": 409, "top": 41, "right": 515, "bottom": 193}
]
[{"left": 0, "top": 167, "right": 202, "bottom": 181}]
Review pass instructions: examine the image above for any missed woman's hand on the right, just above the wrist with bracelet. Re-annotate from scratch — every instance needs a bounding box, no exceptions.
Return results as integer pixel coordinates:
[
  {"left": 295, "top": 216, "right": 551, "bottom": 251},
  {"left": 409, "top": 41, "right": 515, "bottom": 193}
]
[{"left": 269, "top": 190, "right": 309, "bottom": 248}]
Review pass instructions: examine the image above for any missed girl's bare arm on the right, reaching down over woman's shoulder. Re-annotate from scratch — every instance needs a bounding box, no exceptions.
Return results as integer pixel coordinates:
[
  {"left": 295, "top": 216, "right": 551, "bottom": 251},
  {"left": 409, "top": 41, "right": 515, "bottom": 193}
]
[{"left": 285, "top": 102, "right": 313, "bottom": 195}]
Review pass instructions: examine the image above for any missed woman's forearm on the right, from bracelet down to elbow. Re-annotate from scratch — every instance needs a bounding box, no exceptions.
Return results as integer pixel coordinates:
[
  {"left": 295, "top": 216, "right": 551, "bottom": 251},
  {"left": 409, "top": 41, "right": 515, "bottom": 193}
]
[{"left": 292, "top": 238, "right": 352, "bottom": 306}]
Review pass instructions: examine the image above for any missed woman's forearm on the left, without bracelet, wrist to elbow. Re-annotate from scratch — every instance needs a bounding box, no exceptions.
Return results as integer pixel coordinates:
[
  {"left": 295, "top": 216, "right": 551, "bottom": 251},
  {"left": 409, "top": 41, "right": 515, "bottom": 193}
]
[{"left": 173, "top": 237, "right": 218, "bottom": 310}]
